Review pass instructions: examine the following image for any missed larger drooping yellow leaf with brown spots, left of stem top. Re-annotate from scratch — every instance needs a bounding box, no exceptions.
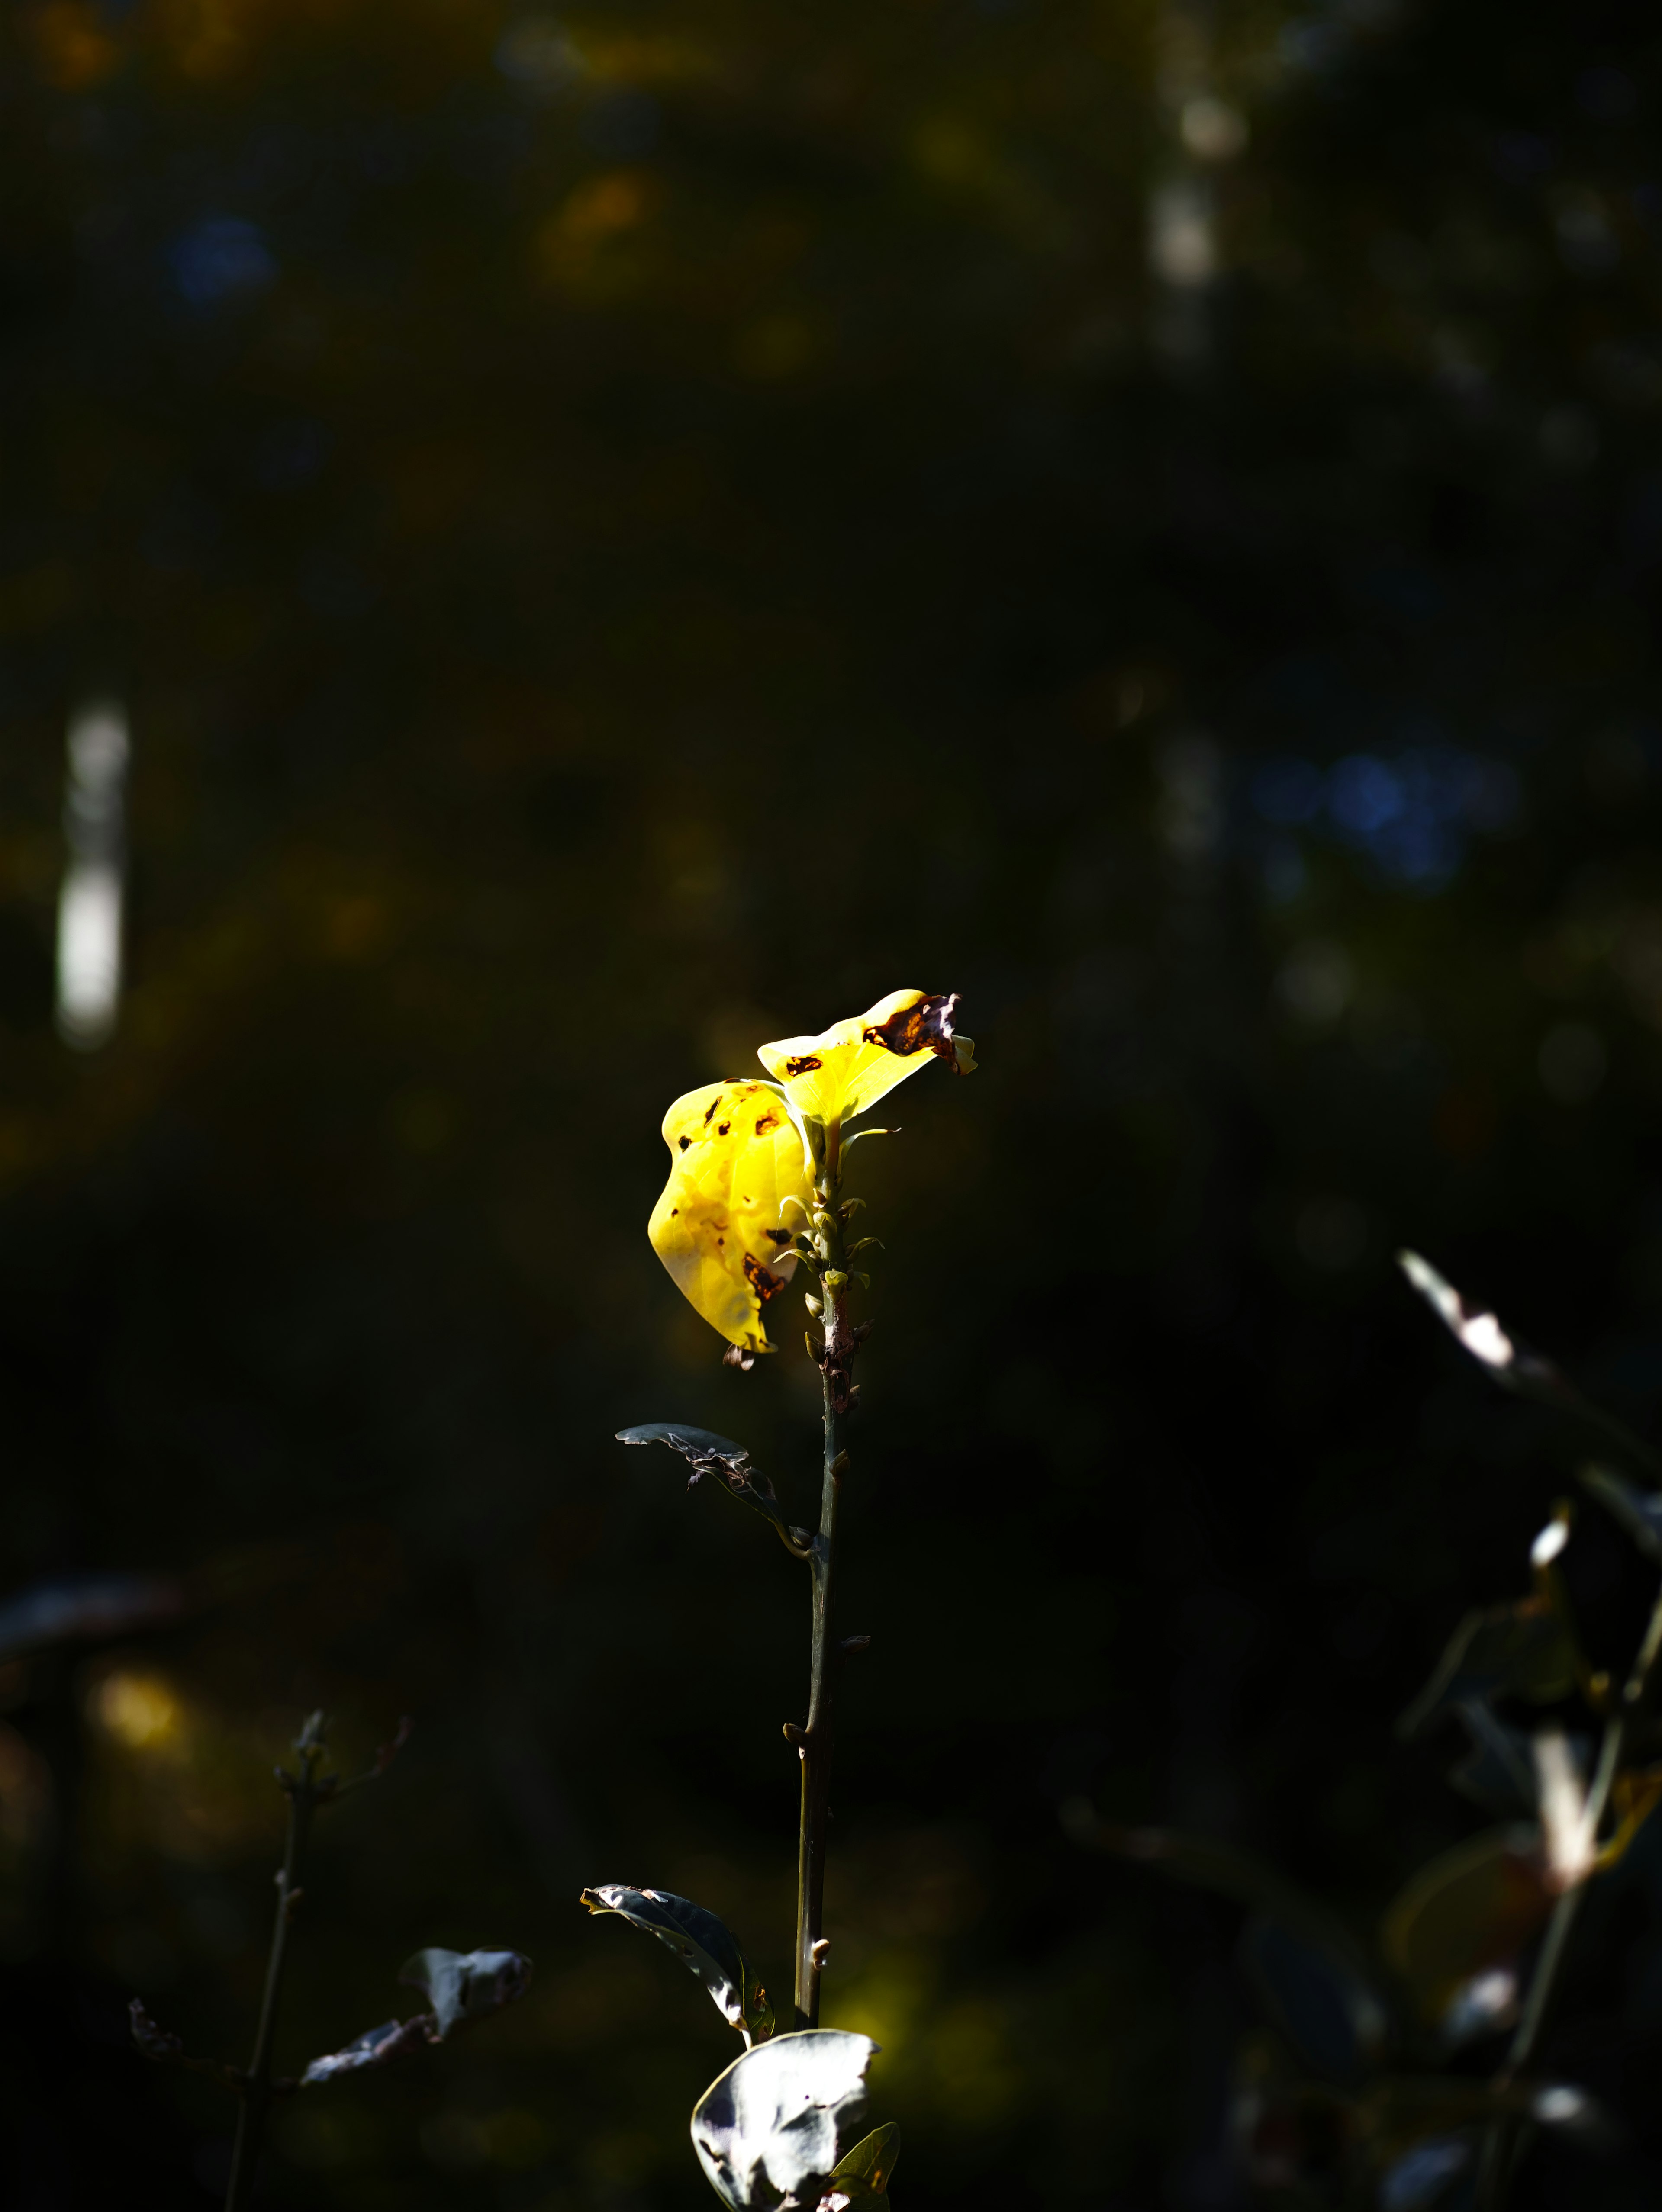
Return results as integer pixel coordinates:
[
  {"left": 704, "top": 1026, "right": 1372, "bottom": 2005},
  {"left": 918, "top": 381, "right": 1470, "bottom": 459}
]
[{"left": 646, "top": 1082, "right": 810, "bottom": 1351}]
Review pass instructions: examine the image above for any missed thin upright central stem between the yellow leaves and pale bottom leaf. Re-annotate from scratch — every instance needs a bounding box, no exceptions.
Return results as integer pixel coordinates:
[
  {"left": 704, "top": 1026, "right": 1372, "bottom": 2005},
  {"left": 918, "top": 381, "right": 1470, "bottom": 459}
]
[{"left": 797, "top": 1122, "right": 854, "bottom": 2029}]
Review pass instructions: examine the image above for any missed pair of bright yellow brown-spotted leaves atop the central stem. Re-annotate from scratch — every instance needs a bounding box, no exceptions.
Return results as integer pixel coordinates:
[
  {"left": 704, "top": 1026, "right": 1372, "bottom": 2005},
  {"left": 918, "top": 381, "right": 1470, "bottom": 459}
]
[{"left": 646, "top": 991, "right": 976, "bottom": 1365}]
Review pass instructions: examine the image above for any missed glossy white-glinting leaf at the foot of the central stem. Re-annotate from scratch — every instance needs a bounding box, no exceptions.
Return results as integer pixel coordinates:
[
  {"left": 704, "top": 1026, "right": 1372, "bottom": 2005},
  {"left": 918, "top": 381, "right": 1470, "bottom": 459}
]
[{"left": 692, "top": 2029, "right": 876, "bottom": 2212}]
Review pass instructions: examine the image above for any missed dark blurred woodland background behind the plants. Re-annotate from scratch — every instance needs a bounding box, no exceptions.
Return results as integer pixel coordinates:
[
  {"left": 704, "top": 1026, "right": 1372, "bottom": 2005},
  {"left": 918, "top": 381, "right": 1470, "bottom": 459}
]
[{"left": 0, "top": 0, "right": 1662, "bottom": 2212}]
